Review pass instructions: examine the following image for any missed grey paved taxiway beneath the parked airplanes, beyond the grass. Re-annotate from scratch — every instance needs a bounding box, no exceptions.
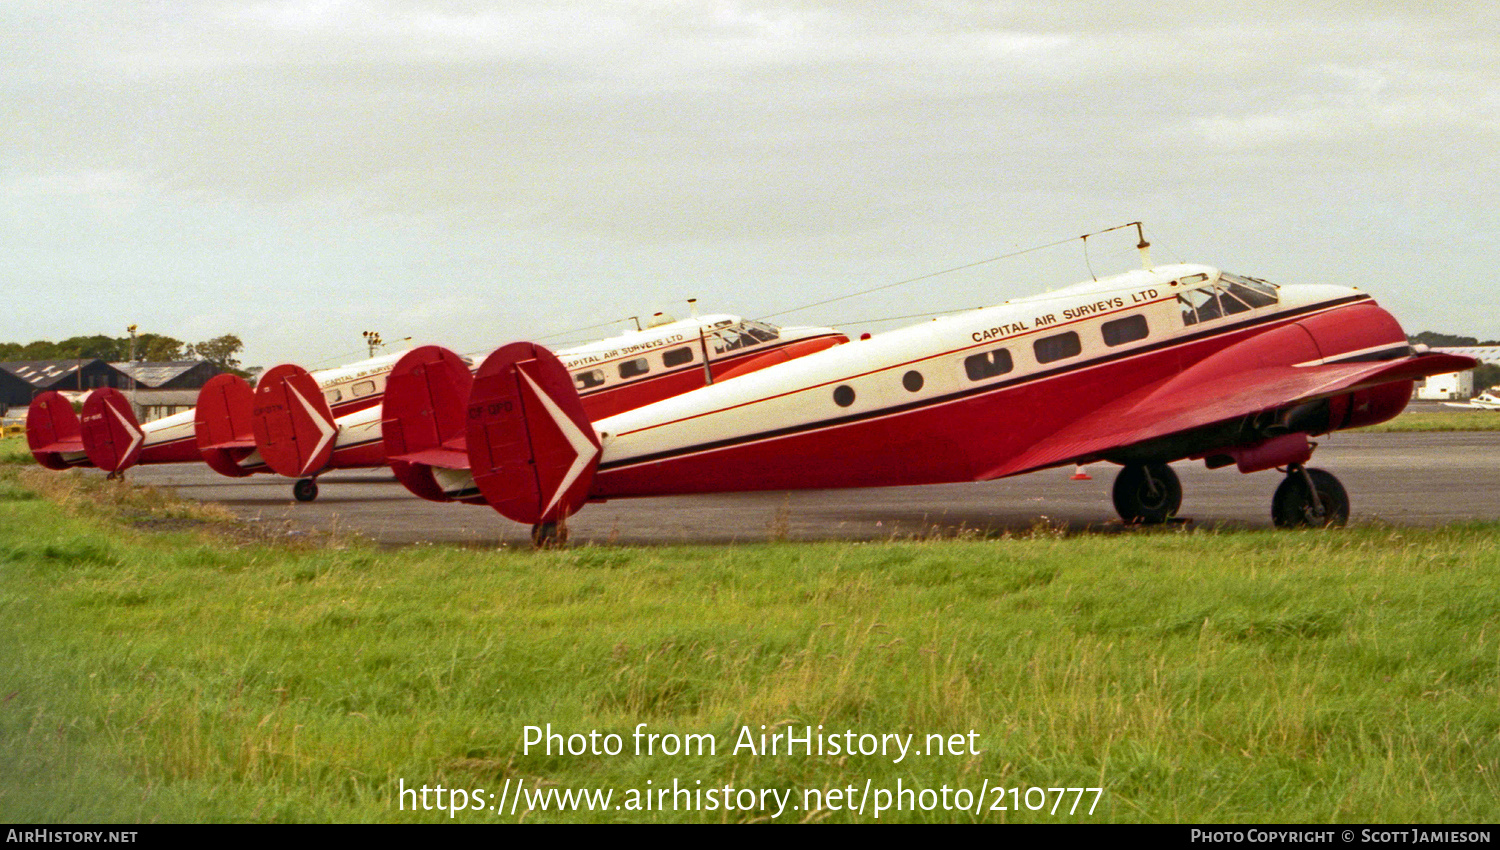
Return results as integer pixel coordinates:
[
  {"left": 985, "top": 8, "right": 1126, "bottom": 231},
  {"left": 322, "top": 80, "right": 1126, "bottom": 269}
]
[{"left": 120, "top": 432, "right": 1500, "bottom": 546}]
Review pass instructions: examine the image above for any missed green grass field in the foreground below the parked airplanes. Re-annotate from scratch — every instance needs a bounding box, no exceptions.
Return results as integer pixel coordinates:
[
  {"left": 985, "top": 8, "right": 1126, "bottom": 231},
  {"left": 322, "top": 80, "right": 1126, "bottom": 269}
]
[{"left": 0, "top": 437, "right": 1500, "bottom": 823}]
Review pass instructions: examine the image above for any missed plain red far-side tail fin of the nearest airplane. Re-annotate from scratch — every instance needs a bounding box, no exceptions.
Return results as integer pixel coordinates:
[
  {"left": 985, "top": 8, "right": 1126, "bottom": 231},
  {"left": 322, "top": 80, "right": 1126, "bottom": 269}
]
[{"left": 381, "top": 345, "right": 474, "bottom": 502}]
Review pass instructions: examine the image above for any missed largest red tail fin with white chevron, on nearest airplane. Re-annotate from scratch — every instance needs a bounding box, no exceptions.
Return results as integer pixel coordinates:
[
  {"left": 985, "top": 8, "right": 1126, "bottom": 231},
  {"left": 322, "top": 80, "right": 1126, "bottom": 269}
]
[{"left": 467, "top": 342, "right": 602, "bottom": 523}]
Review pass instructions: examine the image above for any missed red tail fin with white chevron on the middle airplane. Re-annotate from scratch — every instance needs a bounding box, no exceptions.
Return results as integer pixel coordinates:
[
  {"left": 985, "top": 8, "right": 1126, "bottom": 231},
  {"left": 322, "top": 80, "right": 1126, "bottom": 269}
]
[{"left": 251, "top": 364, "right": 339, "bottom": 478}]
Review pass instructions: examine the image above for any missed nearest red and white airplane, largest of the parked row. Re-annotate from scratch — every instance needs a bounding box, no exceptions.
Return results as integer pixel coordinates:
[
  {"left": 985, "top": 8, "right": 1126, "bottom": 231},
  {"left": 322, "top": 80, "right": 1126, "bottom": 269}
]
[{"left": 465, "top": 265, "right": 1475, "bottom": 543}]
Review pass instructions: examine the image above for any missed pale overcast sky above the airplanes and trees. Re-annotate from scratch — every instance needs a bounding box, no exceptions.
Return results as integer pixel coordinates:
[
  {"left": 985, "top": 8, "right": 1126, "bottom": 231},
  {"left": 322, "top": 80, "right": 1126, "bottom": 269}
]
[{"left": 0, "top": 0, "right": 1500, "bottom": 366}]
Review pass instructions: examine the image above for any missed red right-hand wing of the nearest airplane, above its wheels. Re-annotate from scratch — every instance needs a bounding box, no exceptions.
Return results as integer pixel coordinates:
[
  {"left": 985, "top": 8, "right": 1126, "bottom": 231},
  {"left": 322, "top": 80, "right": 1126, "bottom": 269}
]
[{"left": 980, "top": 354, "right": 1478, "bottom": 481}]
